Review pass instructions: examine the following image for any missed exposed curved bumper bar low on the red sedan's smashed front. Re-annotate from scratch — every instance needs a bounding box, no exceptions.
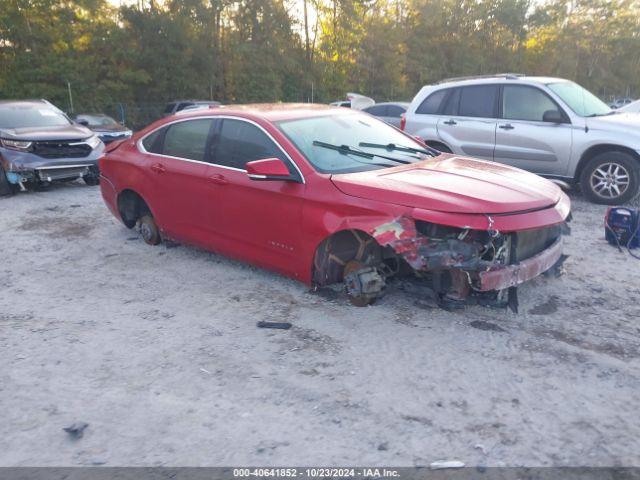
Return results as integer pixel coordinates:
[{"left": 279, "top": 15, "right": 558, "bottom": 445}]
[{"left": 478, "top": 237, "right": 562, "bottom": 292}]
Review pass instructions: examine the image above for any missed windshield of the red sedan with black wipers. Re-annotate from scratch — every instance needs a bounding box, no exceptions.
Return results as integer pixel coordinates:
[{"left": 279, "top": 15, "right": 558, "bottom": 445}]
[{"left": 277, "top": 112, "right": 429, "bottom": 173}]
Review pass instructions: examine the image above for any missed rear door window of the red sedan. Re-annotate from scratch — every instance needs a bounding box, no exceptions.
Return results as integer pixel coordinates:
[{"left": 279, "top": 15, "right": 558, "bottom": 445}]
[{"left": 161, "top": 118, "right": 213, "bottom": 162}]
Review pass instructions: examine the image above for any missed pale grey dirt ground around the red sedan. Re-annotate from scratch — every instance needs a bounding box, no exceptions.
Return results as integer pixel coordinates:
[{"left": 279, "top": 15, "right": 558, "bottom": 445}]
[{"left": 0, "top": 184, "right": 640, "bottom": 466}]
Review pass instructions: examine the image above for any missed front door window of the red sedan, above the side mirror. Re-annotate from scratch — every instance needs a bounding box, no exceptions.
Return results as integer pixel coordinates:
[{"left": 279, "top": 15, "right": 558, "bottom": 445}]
[{"left": 211, "top": 118, "right": 289, "bottom": 170}]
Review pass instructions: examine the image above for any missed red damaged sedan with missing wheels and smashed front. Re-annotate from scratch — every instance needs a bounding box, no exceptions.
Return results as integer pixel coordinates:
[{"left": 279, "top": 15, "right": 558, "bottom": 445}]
[{"left": 100, "top": 104, "right": 570, "bottom": 306}]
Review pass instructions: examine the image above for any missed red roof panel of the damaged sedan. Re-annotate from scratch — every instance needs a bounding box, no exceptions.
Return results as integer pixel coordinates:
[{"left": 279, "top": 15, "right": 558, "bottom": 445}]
[{"left": 170, "top": 103, "right": 350, "bottom": 122}]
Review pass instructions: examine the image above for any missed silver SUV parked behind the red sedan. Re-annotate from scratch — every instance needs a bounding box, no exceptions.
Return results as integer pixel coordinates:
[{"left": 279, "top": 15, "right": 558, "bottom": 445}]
[{"left": 403, "top": 74, "right": 640, "bottom": 205}]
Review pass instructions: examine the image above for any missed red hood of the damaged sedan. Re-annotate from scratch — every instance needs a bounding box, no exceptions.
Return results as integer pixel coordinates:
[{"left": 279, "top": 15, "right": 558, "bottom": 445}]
[{"left": 331, "top": 154, "right": 562, "bottom": 214}]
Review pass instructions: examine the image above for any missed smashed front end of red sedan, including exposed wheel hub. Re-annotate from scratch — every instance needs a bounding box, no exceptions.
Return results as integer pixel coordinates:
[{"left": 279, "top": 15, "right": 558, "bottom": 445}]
[{"left": 336, "top": 194, "right": 570, "bottom": 310}]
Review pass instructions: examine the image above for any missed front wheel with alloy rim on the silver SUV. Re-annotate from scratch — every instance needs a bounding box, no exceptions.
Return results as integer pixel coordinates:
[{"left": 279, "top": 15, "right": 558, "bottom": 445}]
[{"left": 580, "top": 151, "right": 640, "bottom": 205}]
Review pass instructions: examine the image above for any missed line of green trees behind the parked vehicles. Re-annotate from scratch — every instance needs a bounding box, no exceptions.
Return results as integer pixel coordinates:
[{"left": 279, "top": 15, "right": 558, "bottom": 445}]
[{"left": 0, "top": 0, "right": 640, "bottom": 125}]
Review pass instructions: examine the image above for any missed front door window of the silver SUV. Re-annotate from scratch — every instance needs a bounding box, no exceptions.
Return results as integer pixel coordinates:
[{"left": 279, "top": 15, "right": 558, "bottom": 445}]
[{"left": 502, "top": 85, "right": 560, "bottom": 122}]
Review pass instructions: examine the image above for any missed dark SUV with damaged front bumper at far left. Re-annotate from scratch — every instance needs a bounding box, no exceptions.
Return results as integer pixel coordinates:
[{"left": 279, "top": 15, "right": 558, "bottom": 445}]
[{"left": 0, "top": 100, "right": 104, "bottom": 193}]
